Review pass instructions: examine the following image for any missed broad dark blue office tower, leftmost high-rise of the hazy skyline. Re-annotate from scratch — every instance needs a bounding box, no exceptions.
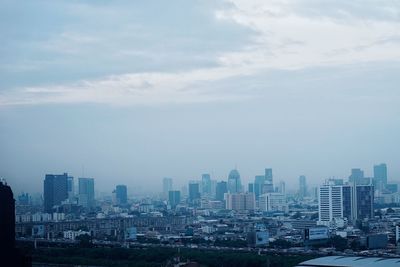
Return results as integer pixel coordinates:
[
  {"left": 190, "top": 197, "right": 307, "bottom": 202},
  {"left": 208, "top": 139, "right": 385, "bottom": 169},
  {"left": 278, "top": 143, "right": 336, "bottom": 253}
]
[{"left": 43, "top": 173, "right": 68, "bottom": 213}]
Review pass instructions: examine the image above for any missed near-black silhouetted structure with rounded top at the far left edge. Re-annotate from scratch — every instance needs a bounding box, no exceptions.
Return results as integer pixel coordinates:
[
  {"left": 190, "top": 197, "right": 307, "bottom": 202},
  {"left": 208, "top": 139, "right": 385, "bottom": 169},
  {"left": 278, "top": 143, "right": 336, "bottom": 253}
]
[{"left": 0, "top": 181, "right": 15, "bottom": 252}]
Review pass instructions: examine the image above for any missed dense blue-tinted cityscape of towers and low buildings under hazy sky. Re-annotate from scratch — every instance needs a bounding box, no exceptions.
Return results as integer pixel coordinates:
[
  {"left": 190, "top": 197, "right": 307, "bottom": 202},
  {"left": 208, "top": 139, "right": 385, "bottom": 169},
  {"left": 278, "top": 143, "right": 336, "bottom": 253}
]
[{"left": 3, "top": 163, "right": 400, "bottom": 266}]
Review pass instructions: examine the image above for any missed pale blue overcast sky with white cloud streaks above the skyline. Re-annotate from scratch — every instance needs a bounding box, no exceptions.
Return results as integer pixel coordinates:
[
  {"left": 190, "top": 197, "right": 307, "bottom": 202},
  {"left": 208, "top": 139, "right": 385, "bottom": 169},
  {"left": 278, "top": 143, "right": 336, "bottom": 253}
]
[{"left": 0, "top": 0, "right": 400, "bottom": 194}]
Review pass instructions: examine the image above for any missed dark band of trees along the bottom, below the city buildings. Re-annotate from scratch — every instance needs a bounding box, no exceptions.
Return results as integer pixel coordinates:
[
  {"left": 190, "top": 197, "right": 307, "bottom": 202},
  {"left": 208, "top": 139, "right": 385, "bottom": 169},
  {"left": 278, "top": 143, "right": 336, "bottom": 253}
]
[{"left": 30, "top": 247, "right": 313, "bottom": 267}]
